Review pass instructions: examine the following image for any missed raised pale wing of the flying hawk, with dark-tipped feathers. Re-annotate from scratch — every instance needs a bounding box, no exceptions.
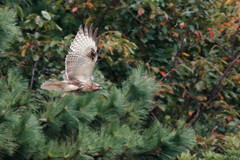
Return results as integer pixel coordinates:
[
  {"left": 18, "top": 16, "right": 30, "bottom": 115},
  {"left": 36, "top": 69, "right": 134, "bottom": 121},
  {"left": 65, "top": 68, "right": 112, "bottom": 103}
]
[{"left": 63, "top": 25, "right": 98, "bottom": 81}]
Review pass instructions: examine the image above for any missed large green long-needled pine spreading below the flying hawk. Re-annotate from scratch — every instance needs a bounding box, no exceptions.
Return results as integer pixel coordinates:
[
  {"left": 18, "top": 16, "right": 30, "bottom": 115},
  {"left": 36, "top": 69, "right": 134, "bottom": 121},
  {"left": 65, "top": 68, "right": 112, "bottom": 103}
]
[{"left": 0, "top": 67, "right": 195, "bottom": 160}]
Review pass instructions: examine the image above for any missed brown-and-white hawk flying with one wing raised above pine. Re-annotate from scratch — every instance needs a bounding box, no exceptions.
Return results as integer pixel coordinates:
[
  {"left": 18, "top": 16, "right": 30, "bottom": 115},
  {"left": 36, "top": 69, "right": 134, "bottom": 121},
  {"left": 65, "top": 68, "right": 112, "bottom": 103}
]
[{"left": 41, "top": 24, "right": 103, "bottom": 92}]
